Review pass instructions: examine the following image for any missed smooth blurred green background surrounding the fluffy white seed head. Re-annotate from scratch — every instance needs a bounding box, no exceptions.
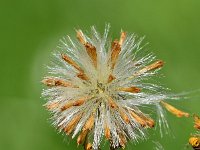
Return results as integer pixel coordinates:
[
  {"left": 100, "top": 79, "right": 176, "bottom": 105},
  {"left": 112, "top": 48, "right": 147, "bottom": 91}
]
[{"left": 0, "top": 0, "right": 200, "bottom": 150}]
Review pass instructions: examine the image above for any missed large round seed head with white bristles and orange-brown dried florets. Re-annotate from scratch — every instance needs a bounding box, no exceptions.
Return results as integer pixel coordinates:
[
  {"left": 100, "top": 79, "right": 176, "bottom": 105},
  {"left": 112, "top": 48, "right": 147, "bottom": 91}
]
[{"left": 42, "top": 25, "right": 189, "bottom": 150}]
